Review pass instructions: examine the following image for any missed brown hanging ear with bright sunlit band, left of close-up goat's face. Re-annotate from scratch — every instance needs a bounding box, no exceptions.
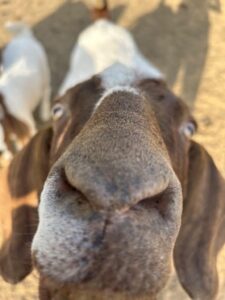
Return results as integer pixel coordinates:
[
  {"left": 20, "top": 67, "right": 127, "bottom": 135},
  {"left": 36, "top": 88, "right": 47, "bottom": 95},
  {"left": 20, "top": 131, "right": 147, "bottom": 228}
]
[{"left": 0, "top": 129, "right": 52, "bottom": 283}]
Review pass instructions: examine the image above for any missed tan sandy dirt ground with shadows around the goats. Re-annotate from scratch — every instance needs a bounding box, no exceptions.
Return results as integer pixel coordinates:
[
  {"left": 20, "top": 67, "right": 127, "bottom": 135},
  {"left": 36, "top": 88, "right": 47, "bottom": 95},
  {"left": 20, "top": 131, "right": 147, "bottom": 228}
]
[{"left": 0, "top": 0, "right": 225, "bottom": 300}]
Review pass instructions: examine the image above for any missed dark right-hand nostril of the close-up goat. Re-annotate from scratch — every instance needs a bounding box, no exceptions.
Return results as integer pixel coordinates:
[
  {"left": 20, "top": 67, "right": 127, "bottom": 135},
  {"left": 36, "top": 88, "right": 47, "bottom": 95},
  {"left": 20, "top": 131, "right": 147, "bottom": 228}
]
[{"left": 134, "top": 187, "right": 171, "bottom": 217}]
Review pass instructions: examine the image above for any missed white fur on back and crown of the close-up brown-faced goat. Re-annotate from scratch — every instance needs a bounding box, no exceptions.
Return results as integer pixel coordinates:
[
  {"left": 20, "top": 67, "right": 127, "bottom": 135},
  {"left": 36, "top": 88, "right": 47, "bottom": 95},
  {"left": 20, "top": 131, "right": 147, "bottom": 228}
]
[{"left": 59, "top": 20, "right": 162, "bottom": 95}]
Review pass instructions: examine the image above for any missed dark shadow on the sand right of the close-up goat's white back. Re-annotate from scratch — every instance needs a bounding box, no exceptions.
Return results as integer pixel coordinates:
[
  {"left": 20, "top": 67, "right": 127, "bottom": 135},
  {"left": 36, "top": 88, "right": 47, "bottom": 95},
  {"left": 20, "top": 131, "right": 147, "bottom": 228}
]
[{"left": 131, "top": 0, "right": 210, "bottom": 106}]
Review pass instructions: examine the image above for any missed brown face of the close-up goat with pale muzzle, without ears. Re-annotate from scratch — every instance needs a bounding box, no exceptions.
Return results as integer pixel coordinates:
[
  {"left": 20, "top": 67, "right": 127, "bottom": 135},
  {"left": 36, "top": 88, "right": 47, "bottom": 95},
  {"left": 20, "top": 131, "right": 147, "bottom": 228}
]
[{"left": 32, "top": 64, "right": 195, "bottom": 295}]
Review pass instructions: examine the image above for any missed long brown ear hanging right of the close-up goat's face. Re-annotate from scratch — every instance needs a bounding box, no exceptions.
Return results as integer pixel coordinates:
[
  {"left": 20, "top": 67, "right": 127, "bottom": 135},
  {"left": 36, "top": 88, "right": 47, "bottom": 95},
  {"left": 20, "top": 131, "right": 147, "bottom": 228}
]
[{"left": 174, "top": 142, "right": 225, "bottom": 300}]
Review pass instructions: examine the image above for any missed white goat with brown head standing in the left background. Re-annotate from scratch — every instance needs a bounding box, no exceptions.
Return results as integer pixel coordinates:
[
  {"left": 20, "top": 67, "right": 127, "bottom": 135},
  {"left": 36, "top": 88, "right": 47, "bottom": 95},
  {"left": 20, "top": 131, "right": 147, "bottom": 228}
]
[{"left": 0, "top": 22, "right": 50, "bottom": 159}]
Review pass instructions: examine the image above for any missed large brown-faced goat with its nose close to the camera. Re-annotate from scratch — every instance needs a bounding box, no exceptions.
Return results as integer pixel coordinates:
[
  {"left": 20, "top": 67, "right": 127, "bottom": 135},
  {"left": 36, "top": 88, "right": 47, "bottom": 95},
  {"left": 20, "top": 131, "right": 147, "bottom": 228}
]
[{"left": 0, "top": 2, "right": 225, "bottom": 300}]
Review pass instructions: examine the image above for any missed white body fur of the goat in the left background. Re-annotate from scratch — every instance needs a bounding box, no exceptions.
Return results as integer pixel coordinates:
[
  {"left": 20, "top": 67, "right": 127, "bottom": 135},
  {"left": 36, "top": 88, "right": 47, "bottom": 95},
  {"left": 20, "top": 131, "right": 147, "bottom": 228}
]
[{"left": 0, "top": 23, "right": 50, "bottom": 142}]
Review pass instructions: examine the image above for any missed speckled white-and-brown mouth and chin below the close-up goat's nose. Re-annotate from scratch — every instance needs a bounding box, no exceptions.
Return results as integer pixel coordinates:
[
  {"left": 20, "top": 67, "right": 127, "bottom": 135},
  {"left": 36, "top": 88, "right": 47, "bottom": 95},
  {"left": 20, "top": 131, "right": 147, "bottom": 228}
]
[{"left": 32, "top": 172, "right": 182, "bottom": 294}]
